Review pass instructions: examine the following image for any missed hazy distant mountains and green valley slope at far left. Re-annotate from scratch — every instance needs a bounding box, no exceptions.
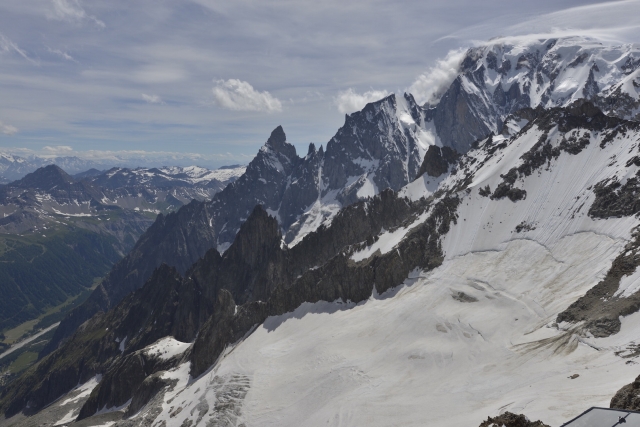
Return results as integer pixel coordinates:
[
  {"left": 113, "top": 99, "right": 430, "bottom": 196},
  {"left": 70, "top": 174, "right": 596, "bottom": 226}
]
[{"left": 0, "top": 165, "right": 244, "bottom": 342}]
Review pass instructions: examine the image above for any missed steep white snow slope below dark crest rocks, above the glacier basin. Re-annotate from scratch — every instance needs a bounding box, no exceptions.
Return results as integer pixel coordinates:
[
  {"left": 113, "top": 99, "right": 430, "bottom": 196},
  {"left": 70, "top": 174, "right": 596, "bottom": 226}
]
[{"left": 443, "top": 123, "right": 638, "bottom": 257}]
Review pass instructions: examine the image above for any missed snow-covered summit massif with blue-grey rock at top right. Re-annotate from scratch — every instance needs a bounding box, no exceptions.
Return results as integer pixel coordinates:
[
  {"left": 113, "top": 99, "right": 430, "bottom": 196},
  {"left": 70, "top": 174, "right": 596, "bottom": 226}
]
[{"left": 459, "top": 37, "right": 640, "bottom": 132}]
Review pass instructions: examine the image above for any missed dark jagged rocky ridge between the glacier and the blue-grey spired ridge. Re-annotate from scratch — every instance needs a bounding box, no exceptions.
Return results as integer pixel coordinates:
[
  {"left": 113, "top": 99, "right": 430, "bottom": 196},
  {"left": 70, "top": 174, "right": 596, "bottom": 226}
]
[{"left": 3, "top": 183, "right": 455, "bottom": 416}]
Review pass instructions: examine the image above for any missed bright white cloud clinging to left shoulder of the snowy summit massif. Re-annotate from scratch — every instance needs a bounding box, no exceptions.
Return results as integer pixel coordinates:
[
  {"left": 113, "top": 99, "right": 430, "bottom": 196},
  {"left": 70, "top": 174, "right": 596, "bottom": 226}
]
[{"left": 408, "top": 49, "right": 466, "bottom": 104}]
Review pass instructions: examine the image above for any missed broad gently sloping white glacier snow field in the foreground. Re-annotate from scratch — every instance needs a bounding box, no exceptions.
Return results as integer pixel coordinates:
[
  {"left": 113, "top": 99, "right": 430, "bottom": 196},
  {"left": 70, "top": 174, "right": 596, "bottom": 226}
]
[{"left": 142, "top": 232, "right": 640, "bottom": 426}]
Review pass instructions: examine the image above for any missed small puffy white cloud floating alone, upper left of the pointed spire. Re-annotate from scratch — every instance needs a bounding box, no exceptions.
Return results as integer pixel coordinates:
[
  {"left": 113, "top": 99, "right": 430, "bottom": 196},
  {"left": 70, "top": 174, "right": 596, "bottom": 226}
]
[{"left": 213, "top": 79, "right": 282, "bottom": 113}]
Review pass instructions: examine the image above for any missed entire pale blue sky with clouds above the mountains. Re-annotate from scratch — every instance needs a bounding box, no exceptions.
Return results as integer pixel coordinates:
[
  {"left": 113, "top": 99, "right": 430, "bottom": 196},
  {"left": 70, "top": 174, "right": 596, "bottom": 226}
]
[{"left": 0, "top": 0, "right": 640, "bottom": 167}]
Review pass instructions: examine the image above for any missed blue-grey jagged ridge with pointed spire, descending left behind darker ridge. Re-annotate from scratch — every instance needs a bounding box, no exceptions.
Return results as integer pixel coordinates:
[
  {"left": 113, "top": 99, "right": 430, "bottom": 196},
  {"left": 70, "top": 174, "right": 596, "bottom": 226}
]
[{"left": 43, "top": 95, "right": 436, "bottom": 355}]
